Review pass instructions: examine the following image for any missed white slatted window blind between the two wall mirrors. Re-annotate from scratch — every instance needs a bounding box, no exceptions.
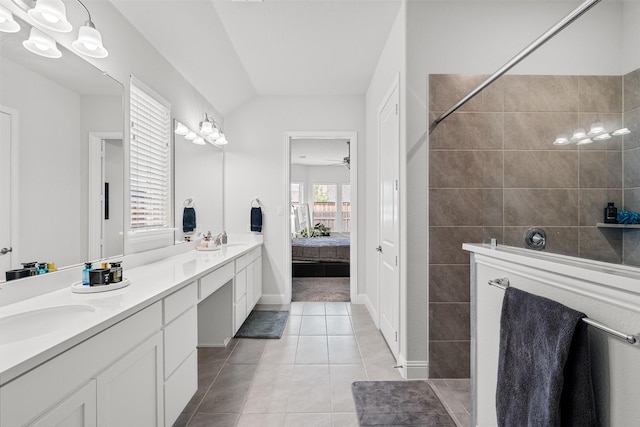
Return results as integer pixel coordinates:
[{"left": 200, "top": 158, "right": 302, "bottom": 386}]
[{"left": 130, "top": 78, "right": 171, "bottom": 231}]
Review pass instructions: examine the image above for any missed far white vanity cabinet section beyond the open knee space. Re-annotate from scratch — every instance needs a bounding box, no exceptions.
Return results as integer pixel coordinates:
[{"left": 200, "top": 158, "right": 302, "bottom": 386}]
[{"left": 233, "top": 247, "right": 262, "bottom": 334}]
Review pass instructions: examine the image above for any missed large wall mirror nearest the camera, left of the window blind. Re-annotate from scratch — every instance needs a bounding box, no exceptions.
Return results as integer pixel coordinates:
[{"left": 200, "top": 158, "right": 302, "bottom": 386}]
[{"left": 0, "top": 13, "right": 124, "bottom": 281}]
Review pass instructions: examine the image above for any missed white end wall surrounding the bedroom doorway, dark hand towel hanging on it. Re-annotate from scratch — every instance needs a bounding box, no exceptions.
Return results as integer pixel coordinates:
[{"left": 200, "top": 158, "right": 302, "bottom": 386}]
[{"left": 225, "top": 96, "right": 369, "bottom": 303}]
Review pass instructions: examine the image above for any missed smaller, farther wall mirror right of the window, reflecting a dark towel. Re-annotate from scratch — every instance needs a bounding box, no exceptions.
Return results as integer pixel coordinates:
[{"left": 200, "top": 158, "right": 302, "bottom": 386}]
[{"left": 174, "top": 120, "right": 224, "bottom": 244}]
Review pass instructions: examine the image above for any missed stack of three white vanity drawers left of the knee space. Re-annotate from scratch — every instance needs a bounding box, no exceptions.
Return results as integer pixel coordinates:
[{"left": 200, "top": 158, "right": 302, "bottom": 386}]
[{"left": 163, "top": 282, "right": 198, "bottom": 426}]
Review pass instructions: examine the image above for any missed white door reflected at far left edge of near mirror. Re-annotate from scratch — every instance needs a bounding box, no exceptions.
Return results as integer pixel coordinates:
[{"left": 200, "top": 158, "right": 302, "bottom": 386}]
[{"left": 0, "top": 111, "right": 15, "bottom": 281}]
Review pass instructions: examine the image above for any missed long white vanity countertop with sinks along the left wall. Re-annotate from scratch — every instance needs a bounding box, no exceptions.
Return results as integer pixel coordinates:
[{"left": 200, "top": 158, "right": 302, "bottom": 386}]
[{"left": 0, "top": 239, "right": 262, "bottom": 385}]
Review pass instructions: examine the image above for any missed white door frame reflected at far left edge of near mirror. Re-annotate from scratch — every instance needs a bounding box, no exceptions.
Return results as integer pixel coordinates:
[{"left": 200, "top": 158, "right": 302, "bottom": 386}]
[{"left": 0, "top": 104, "right": 20, "bottom": 274}]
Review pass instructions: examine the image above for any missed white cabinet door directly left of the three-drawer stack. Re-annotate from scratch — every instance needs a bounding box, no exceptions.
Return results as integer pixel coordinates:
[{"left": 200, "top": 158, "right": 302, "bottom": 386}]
[{"left": 96, "top": 332, "right": 164, "bottom": 427}]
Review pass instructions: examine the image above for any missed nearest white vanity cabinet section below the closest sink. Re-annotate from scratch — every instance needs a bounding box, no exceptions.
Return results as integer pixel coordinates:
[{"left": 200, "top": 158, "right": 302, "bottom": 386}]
[{"left": 0, "top": 302, "right": 164, "bottom": 427}]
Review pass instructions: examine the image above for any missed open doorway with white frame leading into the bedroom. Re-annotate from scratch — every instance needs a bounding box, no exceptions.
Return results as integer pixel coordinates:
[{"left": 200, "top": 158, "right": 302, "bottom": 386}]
[{"left": 285, "top": 132, "right": 357, "bottom": 302}]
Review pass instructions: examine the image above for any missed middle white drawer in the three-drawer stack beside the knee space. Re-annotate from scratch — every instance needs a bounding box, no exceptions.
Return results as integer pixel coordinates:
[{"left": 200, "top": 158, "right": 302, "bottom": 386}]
[{"left": 164, "top": 306, "right": 198, "bottom": 379}]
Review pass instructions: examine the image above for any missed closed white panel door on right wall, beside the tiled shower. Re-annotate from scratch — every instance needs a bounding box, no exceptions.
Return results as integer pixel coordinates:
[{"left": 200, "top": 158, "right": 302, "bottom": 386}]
[{"left": 376, "top": 83, "right": 400, "bottom": 359}]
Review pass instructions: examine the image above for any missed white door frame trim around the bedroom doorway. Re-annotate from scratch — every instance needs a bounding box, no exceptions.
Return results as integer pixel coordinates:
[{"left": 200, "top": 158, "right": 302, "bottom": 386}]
[{"left": 284, "top": 131, "right": 358, "bottom": 304}]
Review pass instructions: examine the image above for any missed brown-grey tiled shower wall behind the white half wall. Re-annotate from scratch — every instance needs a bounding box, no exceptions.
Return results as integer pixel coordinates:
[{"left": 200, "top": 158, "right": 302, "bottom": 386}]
[{"left": 429, "top": 70, "right": 640, "bottom": 378}]
